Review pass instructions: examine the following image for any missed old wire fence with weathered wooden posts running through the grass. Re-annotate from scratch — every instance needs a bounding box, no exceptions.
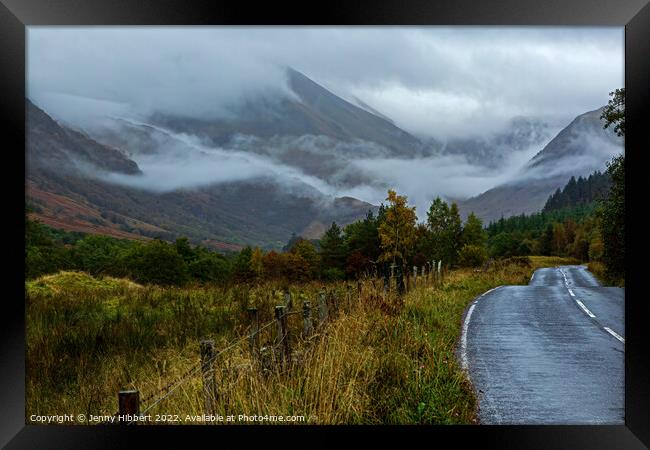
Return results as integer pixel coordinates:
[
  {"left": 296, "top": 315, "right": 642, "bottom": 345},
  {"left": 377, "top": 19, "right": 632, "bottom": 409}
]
[{"left": 104, "top": 260, "right": 444, "bottom": 425}]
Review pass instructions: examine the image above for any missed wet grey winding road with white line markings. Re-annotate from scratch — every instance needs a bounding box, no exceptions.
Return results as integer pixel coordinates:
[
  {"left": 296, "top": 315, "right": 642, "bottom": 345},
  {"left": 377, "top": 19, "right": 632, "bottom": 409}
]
[{"left": 459, "top": 266, "right": 625, "bottom": 425}]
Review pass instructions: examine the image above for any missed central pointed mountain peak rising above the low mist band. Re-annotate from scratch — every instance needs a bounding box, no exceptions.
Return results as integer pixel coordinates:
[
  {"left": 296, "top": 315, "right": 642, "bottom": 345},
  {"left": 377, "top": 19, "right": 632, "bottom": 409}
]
[{"left": 79, "top": 69, "right": 426, "bottom": 188}]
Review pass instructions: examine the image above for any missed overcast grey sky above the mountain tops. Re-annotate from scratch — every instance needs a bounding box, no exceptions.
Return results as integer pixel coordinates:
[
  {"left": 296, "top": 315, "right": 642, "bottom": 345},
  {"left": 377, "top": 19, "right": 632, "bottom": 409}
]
[{"left": 27, "top": 27, "right": 624, "bottom": 139}]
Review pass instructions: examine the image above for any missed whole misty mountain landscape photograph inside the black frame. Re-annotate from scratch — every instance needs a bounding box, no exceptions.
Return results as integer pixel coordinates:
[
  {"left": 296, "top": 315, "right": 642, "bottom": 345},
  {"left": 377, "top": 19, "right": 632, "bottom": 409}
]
[{"left": 19, "top": 25, "right": 624, "bottom": 427}]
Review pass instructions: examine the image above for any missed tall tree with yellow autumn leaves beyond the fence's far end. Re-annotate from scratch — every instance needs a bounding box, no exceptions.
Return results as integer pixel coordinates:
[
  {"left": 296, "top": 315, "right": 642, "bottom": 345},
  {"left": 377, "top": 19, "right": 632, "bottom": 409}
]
[{"left": 379, "top": 189, "right": 417, "bottom": 264}]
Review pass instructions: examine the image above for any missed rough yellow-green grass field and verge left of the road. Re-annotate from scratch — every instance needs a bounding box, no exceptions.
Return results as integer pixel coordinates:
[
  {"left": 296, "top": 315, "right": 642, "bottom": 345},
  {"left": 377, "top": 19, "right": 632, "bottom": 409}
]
[{"left": 26, "top": 257, "right": 572, "bottom": 424}]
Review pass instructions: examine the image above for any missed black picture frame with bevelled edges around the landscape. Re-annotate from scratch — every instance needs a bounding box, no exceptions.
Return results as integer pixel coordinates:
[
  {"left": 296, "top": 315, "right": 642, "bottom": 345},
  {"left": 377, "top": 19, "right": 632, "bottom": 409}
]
[{"left": 0, "top": 0, "right": 650, "bottom": 449}]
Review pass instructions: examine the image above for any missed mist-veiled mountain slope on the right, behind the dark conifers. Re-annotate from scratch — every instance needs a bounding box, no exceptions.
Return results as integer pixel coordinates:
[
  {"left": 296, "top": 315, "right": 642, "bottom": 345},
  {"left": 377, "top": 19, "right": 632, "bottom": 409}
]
[{"left": 457, "top": 108, "right": 624, "bottom": 223}]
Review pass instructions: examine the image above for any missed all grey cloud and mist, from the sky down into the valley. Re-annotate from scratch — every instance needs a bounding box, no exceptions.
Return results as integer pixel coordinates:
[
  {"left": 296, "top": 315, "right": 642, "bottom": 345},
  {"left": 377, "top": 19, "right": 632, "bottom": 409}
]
[{"left": 26, "top": 27, "right": 624, "bottom": 225}]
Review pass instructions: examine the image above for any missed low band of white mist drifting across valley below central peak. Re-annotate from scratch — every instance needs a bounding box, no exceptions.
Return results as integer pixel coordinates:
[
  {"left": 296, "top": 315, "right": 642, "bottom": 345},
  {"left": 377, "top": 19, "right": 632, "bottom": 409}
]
[{"left": 83, "top": 120, "right": 560, "bottom": 219}]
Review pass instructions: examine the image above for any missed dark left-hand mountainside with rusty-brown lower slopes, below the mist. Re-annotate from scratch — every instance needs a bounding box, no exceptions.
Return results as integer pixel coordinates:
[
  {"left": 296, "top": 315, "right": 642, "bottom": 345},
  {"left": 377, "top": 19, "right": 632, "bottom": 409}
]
[{"left": 26, "top": 101, "right": 376, "bottom": 249}]
